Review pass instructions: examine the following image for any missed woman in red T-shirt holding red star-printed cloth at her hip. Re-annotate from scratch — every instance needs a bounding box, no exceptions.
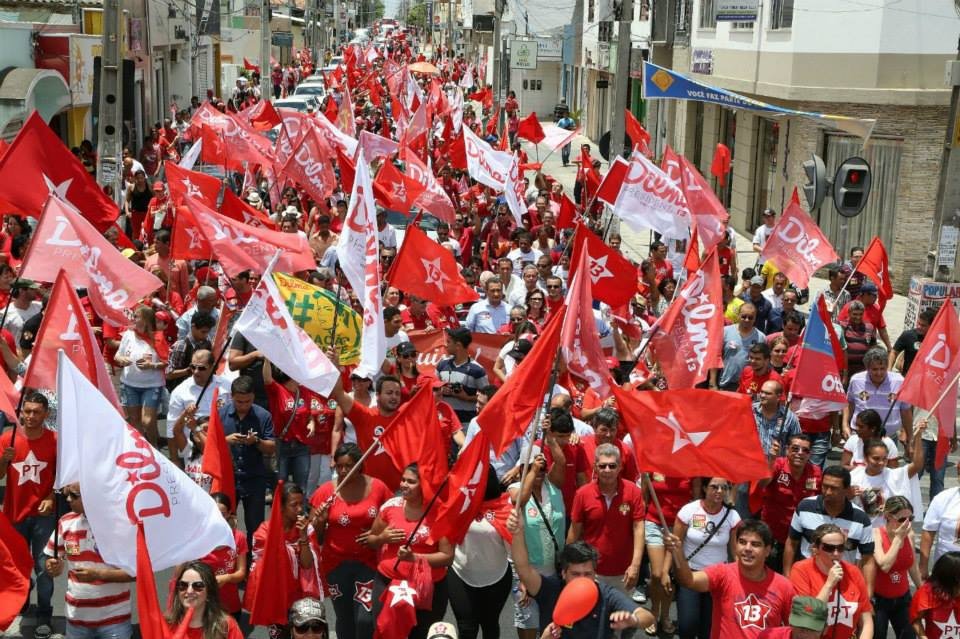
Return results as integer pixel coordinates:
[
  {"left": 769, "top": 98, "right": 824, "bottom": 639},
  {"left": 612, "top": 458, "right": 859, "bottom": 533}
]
[{"left": 367, "top": 464, "right": 453, "bottom": 639}]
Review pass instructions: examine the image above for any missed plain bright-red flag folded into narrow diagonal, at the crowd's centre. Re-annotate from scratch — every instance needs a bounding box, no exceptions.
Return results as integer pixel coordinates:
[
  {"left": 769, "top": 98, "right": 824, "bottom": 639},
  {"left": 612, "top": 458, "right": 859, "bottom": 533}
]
[{"left": 477, "top": 307, "right": 565, "bottom": 457}]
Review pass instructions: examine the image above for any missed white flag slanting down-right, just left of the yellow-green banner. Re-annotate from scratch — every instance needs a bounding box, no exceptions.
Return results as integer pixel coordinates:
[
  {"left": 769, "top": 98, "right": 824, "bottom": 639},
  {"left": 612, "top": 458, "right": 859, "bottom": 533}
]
[{"left": 236, "top": 252, "right": 340, "bottom": 396}]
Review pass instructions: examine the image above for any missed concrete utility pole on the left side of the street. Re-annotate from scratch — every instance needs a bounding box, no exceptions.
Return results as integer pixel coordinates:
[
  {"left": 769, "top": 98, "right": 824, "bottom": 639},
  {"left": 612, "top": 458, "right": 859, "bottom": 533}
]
[{"left": 97, "top": 0, "right": 123, "bottom": 203}]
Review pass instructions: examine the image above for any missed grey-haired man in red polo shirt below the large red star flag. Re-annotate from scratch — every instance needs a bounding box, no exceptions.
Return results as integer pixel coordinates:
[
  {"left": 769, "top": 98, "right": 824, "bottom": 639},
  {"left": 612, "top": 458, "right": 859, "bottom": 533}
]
[{"left": 567, "top": 444, "right": 646, "bottom": 593}]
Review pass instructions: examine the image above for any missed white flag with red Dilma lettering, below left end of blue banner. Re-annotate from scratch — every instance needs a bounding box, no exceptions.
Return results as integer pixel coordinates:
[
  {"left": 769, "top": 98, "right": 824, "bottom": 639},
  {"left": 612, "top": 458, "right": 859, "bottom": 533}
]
[{"left": 613, "top": 151, "right": 690, "bottom": 237}]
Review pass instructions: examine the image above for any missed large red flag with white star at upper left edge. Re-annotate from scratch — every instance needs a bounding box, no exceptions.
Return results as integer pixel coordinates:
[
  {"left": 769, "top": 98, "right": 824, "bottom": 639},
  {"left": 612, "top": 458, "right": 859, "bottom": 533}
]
[{"left": 0, "top": 111, "right": 119, "bottom": 230}]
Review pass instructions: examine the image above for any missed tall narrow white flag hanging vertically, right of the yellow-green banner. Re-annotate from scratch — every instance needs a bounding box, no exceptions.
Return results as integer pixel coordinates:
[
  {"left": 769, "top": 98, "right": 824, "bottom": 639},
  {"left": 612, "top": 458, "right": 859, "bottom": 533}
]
[{"left": 337, "top": 153, "right": 387, "bottom": 378}]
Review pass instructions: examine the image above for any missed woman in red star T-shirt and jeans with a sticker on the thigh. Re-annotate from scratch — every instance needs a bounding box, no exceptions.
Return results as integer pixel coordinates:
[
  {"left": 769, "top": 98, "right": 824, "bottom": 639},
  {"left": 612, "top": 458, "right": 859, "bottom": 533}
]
[{"left": 310, "top": 443, "right": 393, "bottom": 639}]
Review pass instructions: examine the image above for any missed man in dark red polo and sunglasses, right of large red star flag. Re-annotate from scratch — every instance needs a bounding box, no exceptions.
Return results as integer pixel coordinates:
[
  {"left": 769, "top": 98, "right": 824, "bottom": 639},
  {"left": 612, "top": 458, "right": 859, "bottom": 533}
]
[{"left": 758, "top": 434, "right": 821, "bottom": 573}]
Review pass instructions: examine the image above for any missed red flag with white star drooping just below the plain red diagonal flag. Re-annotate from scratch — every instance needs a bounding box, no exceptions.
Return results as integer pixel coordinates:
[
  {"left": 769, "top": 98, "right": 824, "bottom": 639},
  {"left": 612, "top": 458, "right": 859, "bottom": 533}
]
[{"left": 433, "top": 430, "right": 490, "bottom": 545}]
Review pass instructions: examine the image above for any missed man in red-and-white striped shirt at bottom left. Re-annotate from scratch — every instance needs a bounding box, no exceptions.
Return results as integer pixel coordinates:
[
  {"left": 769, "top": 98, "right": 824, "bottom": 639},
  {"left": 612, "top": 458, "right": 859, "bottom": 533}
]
[{"left": 43, "top": 484, "right": 134, "bottom": 639}]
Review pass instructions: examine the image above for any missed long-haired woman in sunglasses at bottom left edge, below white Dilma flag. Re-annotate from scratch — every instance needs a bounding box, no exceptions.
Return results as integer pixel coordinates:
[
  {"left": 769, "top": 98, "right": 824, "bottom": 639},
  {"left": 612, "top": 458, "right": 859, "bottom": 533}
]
[{"left": 167, "top": 561, "right": 243, "bottom": 639}]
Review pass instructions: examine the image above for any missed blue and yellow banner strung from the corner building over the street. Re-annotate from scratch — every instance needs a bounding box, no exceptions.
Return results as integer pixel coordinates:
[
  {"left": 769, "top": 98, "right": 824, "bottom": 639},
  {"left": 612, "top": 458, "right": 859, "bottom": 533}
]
[{"left": 643, "top": 62, "right": 877, "bottom": 144}]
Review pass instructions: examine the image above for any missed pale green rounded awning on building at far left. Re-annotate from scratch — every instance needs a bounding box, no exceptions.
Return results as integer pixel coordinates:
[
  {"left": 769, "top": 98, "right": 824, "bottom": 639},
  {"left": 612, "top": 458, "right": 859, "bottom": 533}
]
[{"left": 0, "top": 67, "right": 73, "bottom": 138}]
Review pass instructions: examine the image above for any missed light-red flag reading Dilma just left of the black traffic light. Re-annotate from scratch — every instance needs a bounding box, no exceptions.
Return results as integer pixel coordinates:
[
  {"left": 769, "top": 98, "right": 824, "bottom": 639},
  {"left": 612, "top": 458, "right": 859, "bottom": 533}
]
[{"left": 760, "top": 204, "right": 840, "bottom": 288}]
